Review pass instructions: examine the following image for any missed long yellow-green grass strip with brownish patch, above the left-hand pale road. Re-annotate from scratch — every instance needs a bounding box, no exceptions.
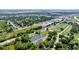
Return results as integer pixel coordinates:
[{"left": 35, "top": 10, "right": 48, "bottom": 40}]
[{"left": 0, "top": 24, "right": 39, "bottom": 42}]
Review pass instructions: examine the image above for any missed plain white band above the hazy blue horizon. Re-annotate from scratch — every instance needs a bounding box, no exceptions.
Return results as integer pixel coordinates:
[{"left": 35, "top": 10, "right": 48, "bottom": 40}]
[{"left": 0, "top": 0, "right": 79, "bottom": 9}]
